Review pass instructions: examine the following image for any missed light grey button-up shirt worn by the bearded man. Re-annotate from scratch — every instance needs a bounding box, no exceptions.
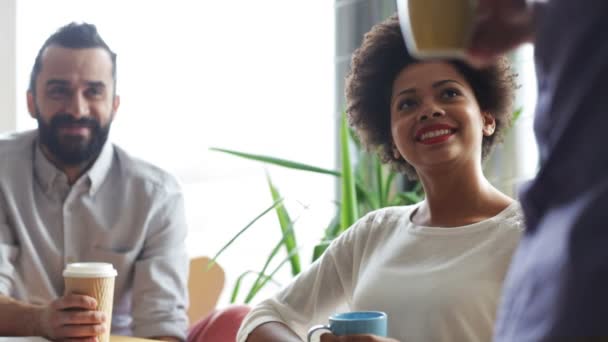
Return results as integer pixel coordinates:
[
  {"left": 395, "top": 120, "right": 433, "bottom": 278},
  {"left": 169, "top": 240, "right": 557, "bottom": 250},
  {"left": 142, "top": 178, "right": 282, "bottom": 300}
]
[{"left": 0, "top": 131, "right": 188, "bottom": 338}]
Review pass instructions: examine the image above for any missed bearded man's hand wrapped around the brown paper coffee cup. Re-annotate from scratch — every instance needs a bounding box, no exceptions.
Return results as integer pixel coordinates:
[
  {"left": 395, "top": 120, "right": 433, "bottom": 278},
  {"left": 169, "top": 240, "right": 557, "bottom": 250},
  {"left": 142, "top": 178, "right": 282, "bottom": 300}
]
[{"left": 39, "top": 294, "right": 106, "bottom": 341}]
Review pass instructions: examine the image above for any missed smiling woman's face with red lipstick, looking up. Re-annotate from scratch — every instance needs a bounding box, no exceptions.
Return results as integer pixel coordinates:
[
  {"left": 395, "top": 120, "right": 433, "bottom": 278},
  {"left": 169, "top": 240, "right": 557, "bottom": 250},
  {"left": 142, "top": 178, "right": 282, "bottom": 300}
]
[{"left": 390, "top": 62, "right": 495, "bottom": 173}]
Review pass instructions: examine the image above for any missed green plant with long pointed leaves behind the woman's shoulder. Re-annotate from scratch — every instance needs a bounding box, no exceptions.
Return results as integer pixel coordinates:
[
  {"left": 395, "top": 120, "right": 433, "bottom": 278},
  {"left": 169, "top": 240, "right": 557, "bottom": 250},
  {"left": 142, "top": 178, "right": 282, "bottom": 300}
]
[{"left": 211, "top": 114, "right": 423, "bottom": 303}]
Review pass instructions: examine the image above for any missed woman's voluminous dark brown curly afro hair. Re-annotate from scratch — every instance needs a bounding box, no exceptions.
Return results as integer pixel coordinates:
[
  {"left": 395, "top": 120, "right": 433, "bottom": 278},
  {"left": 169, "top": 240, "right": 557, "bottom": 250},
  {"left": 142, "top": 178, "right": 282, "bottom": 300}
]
[{"left": 346, "top": 14, "right": 516, "bottom": 179}]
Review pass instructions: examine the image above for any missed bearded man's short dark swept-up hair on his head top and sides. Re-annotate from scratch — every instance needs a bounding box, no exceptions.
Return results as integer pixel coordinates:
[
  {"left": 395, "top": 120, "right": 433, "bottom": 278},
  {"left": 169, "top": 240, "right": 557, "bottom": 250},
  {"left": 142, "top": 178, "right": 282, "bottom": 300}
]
[{"left": 28, "top": 23, "right": 116, "bottom": 95}]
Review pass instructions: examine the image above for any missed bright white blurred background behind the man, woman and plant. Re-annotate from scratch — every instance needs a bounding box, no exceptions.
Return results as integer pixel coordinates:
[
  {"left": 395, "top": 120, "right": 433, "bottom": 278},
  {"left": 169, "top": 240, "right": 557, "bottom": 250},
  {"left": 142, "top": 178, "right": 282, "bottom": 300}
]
[{"left": 0, "top": 0, "right": 537, "bottom": 305}]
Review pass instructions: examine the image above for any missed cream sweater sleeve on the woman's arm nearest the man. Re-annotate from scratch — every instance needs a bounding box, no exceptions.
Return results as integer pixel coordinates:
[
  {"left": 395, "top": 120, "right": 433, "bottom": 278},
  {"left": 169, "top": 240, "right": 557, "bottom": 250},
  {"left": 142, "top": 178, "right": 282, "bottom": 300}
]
[{"left": 237, "top": 218, "right": 369, "bottom": 342}]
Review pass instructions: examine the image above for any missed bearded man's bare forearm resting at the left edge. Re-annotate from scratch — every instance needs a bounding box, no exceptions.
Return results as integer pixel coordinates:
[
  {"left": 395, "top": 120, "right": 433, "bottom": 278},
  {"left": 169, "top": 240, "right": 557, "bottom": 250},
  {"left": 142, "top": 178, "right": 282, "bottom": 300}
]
[{"left": 0, "top": 295, "right": 44, "bottom": 336}]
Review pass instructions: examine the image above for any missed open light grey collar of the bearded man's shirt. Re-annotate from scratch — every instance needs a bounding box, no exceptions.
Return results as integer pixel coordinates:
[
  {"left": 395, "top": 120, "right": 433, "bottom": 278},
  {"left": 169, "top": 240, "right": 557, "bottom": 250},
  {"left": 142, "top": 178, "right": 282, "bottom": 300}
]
[{"left": 34, "top": 139, "right": 114, "bottom": 195}]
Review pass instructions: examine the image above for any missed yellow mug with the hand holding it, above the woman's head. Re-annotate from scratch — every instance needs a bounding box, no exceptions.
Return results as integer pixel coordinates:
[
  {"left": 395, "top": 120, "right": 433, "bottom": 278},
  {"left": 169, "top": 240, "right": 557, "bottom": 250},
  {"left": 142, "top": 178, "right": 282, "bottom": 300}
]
[{"left": 397, "top": 0, "right": 546, "bottom": 66}]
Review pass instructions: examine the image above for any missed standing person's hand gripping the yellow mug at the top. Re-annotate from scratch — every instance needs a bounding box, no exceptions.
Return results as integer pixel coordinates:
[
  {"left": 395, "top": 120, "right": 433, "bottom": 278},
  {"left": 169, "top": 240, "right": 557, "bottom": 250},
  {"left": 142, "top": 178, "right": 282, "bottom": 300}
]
[{"left": 468, "top": 0, "right": 534, "bottom": 66}]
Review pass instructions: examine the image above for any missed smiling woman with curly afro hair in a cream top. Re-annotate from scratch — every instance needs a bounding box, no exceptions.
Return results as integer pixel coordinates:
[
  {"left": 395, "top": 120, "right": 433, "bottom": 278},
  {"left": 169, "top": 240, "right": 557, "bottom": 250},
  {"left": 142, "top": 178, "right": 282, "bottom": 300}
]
[{"left": 238, "top": 16, "right": 523, "bottom": 342}]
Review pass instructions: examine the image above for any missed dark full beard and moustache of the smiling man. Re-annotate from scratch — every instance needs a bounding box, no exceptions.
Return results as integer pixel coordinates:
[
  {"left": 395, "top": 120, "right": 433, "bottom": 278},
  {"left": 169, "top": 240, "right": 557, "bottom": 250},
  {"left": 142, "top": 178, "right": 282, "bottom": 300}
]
[{"left": 36, "top": 110, "right": 112, "bottom": 166}]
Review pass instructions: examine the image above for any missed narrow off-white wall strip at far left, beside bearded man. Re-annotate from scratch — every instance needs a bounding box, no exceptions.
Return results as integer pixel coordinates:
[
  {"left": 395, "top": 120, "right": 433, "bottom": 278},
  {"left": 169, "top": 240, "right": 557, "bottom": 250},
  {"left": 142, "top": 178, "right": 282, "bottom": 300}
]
[{"left": 0, "top": 0, "right": 17, "bottom": 133}]
